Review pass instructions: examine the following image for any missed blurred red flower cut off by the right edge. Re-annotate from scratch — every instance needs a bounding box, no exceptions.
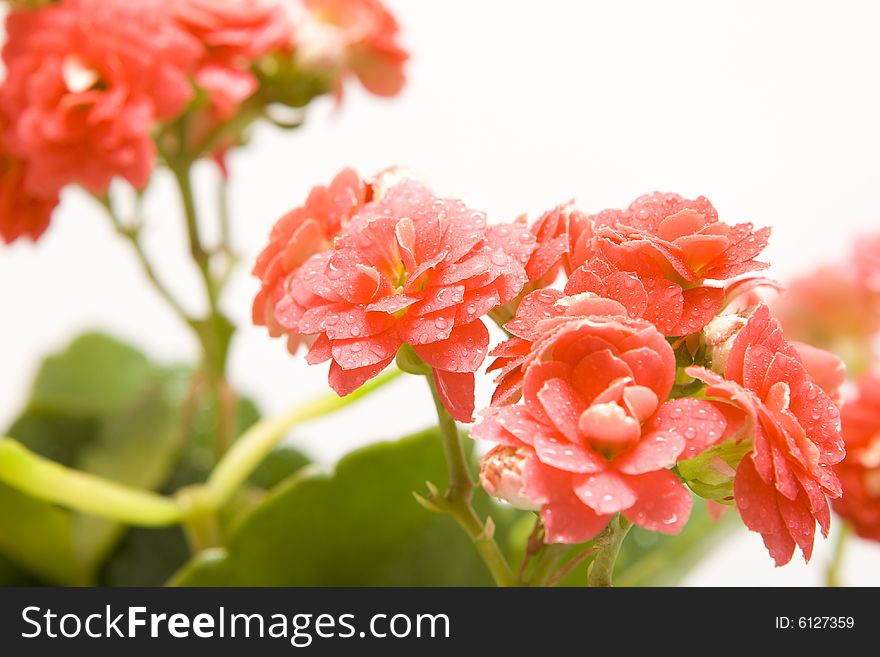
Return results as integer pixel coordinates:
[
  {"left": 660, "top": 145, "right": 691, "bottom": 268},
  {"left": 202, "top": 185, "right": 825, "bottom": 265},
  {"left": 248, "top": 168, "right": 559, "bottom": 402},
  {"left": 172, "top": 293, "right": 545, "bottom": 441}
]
[{"left": 834, "top": 371, "right": 880, "bottom": 541}]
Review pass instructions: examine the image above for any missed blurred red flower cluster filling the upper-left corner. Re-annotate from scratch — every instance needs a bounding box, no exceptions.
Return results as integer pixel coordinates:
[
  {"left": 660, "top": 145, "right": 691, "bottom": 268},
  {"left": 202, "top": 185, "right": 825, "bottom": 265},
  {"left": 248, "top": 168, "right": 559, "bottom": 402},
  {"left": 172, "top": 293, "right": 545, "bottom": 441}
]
[{"left": 0, "top": 0, "right": 406, "bottom": 242}]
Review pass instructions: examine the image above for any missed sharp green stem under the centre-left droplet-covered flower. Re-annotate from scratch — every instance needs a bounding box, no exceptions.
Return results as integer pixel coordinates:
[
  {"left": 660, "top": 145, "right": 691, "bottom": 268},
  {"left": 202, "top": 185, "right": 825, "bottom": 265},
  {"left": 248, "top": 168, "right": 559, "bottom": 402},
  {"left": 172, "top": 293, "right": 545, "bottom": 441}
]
[{"left": 425, "top": 376, "right": 517, "bottom": 586}]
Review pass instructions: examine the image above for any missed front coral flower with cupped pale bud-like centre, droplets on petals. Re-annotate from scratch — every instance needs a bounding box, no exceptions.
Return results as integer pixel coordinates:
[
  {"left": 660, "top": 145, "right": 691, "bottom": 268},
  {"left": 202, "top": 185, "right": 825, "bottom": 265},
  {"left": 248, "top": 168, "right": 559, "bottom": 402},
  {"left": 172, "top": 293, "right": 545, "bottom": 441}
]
[{"left": 471, "top": 312, "right": 726, "bottom": 543}]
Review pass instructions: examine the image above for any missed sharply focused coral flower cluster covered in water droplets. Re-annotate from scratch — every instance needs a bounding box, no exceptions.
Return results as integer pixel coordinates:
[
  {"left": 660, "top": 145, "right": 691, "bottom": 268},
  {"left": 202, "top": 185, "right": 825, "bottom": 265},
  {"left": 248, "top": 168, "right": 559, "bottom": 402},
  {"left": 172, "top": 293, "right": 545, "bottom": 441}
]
[{"left": 255, "top": 178, "right": 844, "bottom": 564}]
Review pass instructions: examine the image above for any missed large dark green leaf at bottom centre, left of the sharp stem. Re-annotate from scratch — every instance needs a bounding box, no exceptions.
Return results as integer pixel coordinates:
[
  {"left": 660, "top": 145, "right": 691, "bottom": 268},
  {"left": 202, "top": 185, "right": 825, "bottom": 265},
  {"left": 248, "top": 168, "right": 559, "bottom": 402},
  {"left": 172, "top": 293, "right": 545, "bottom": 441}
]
[{"left": 173, "top": 430, "right": 509, "bottom": 586}]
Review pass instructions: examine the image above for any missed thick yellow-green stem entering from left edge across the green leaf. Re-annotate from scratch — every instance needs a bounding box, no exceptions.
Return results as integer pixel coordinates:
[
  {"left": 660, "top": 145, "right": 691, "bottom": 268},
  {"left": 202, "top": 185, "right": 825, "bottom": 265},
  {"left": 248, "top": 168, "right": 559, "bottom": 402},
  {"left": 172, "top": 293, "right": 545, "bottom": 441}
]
[{"left": 0, "top": 438, "right": 184, "bottom": 527}]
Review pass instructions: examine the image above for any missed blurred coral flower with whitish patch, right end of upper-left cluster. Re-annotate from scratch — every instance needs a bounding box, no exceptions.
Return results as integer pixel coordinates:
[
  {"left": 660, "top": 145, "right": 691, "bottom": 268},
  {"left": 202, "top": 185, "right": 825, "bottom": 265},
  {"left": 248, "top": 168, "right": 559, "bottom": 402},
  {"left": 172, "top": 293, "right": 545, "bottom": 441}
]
[{"left": 295, "top": 0, "right": 409, "bottom": 96}]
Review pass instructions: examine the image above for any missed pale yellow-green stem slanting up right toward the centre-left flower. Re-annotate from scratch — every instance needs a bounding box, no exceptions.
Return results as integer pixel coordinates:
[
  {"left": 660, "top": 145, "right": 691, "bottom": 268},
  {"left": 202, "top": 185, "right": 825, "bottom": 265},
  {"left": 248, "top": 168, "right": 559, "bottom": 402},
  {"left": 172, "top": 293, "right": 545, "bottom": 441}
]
[{"left": 205, "top": 369, "right": 401, "bottom": 509}]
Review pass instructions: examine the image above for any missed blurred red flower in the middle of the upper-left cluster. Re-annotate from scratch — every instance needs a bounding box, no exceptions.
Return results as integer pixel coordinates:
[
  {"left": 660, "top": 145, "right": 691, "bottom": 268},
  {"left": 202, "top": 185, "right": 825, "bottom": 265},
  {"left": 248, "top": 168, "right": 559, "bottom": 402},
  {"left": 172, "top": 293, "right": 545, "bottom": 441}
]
[{"left": 174, "top": 0, "right": 293, "bottom": 121}]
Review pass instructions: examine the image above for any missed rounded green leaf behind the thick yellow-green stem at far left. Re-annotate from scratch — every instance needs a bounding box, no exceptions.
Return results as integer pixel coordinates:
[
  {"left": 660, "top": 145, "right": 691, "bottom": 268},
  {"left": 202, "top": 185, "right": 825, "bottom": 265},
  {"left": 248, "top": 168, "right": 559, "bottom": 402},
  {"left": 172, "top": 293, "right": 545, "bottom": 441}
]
[{"left": 0, "top": 333, "right": 187, "bottom": 585}]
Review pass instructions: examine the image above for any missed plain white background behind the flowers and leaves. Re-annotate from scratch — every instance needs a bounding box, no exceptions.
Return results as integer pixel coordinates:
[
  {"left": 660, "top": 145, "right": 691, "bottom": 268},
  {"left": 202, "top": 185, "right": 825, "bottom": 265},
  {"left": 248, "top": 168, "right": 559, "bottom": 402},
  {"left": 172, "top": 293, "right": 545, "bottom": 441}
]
[{"left": 0, "top": 0, "right": 880, "bottom": 585}]
